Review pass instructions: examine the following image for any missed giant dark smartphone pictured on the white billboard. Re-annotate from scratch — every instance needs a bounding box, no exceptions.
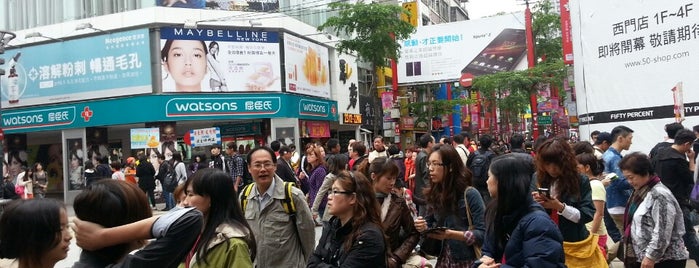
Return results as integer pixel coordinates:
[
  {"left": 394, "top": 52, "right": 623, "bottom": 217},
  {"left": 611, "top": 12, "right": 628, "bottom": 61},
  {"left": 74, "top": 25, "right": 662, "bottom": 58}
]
[{"left": 461, "top": 28, "right": 527, "bottom": 76}]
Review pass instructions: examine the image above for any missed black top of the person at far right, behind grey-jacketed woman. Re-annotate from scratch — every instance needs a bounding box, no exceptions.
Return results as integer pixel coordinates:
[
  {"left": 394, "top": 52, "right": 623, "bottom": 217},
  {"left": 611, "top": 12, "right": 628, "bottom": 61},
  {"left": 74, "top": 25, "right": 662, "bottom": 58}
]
[{"left": 653, "top": 147, "right": 694, "bottom": 206}]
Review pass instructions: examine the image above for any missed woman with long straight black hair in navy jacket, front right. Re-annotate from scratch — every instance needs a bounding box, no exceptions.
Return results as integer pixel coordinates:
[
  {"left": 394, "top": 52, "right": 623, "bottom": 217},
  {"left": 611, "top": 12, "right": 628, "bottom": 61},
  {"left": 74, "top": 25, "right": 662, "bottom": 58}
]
[{"left": 477, "top": 154, "right": 565, "bottom": 268}]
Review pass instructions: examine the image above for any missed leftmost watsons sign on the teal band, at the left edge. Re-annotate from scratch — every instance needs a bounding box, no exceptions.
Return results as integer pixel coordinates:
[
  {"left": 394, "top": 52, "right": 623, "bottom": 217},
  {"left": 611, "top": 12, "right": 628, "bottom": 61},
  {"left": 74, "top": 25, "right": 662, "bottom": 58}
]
[{"left": 2, "top": 106, "right": 76, "bottom": 130}]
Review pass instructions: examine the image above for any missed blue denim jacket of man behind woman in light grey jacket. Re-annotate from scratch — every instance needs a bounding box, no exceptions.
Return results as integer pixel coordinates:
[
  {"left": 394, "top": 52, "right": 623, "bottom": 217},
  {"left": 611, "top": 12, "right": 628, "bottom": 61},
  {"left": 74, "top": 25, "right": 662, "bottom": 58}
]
[{"left": 602, "top": 147, "right": 632, "bottom": 208}]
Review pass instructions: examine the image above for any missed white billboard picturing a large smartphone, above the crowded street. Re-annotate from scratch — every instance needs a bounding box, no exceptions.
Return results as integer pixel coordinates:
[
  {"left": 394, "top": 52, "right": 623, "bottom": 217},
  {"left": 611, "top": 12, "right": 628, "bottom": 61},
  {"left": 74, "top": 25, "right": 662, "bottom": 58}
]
[{"left": 398, "top": 13, "right": 526, "bottom": 84}]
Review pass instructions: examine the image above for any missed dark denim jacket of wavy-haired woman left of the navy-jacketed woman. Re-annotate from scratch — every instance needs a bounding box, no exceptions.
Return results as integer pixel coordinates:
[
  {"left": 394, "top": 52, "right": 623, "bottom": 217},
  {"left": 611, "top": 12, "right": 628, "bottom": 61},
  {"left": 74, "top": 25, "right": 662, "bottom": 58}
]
[{"left": 425, "top": 187, "right": 485, "bottom": 261}]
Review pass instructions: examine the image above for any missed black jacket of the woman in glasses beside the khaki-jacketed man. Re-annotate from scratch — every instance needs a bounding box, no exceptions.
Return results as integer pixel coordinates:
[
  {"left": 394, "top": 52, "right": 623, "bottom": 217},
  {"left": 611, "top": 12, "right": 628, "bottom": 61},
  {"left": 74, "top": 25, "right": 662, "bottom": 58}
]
[{"left": 307, "top": 217, "right": 386, "bottom": 268}]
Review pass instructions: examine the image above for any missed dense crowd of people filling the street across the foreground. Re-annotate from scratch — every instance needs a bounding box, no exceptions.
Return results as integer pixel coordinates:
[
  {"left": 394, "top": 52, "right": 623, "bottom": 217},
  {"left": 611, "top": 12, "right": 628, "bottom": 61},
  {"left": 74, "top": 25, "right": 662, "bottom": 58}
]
[{"left": 0, "top": 123, "right": 699, "bottom": 268}]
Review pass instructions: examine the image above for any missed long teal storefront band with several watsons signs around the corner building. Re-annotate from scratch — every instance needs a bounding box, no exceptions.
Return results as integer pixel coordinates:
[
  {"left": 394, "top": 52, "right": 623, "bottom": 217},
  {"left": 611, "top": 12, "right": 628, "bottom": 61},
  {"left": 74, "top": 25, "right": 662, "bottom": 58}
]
[{"left": 2, "top": 93, "right": 338, "bottom": 134}]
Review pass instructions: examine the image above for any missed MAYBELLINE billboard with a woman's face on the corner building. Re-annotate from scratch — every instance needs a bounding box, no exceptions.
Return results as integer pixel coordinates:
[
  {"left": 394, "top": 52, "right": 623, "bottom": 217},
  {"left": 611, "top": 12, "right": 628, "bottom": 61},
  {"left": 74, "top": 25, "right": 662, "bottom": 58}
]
[{"left": 160, "top": 28, "right": 281, "bottom": 92}]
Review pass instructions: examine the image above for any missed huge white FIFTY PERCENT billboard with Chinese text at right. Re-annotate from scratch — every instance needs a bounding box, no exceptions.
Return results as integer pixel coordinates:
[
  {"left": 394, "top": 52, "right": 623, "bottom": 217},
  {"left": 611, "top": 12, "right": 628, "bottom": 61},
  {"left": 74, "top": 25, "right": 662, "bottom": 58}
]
[{"left": 570, "top": 0, "right": 699, "bottom": 152}]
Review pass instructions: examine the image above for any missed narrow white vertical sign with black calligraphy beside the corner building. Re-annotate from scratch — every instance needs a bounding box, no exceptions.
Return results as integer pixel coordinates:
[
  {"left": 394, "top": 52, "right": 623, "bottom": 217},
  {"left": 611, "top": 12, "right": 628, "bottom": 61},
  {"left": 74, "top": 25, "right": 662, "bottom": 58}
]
[{"left": 332, "top": 51, "right": 362, "bottom": 125}]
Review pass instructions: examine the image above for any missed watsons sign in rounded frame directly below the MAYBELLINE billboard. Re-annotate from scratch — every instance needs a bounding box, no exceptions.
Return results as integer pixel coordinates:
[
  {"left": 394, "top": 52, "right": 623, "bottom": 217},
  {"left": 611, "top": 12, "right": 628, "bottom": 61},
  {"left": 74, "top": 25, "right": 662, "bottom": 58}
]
[{"left": 165, "top": 97, "right": 281, "bottom": 117}]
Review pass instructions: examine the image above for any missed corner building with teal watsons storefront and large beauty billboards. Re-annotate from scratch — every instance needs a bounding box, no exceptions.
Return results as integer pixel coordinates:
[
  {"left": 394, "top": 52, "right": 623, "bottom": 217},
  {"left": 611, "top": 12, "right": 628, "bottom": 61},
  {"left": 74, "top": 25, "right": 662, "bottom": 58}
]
[{"left": 0, "top": 5, "right": 366, "bottom": 204}]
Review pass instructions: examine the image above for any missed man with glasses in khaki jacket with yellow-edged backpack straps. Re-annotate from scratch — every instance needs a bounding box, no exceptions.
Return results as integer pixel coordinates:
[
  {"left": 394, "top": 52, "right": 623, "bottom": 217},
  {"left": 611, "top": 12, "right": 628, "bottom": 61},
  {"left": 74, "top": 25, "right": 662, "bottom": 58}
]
[{"left": 241, "top": 147, "right": 315, "bottom": 267}]
